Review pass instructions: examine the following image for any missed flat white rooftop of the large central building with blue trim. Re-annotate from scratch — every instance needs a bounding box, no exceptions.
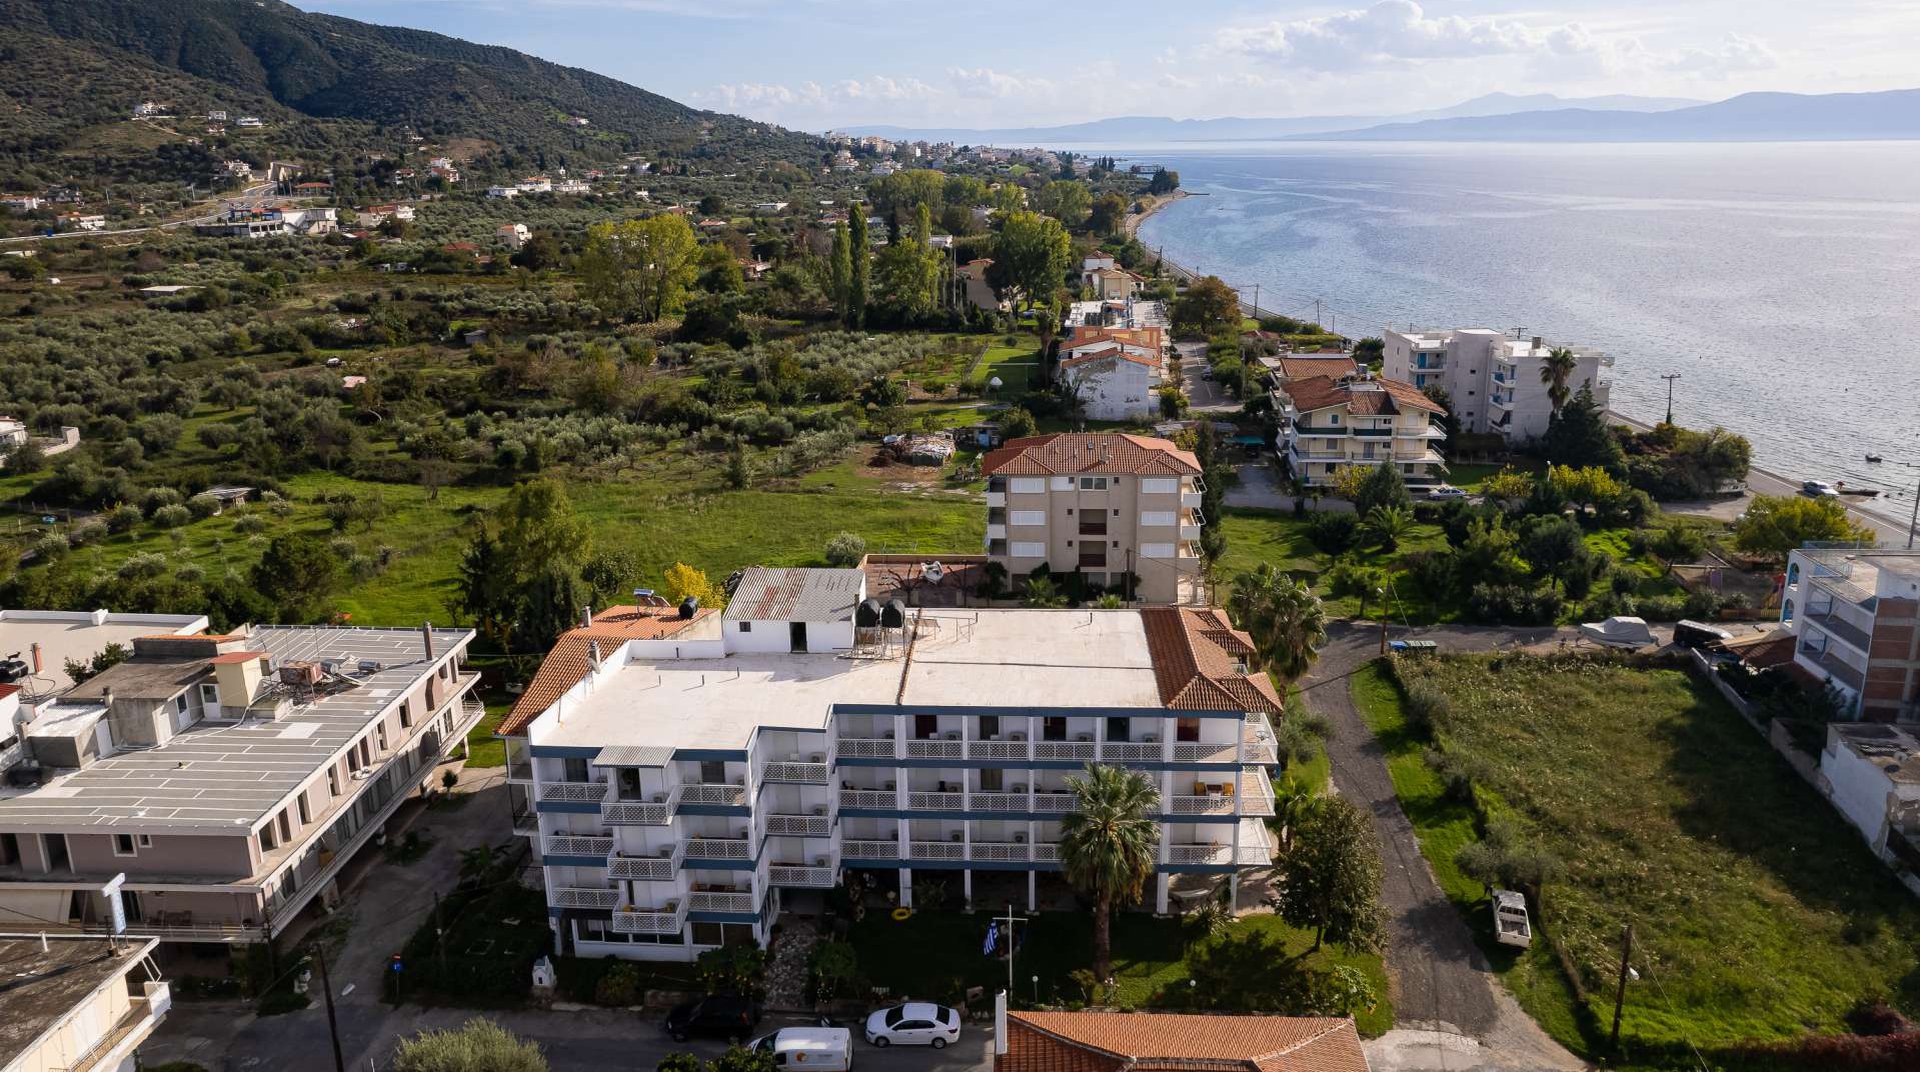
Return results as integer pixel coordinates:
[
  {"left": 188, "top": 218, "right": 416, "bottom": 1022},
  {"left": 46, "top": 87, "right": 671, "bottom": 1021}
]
[{"left": 538, "top": 609, "right": 1162, "bottom": 749}]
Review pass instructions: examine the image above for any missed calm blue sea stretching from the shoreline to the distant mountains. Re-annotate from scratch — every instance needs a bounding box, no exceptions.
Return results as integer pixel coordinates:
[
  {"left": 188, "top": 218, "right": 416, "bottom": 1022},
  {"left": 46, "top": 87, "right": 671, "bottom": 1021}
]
[{"left": 1127, "top": 142, "right": 1920, "bottom": 513}]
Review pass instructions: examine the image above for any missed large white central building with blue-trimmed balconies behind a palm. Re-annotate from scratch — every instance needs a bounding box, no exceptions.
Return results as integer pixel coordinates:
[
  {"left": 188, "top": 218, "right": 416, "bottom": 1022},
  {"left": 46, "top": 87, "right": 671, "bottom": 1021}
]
[{"left": 501, "top": 569, "right": 1281, "bottom": 961}]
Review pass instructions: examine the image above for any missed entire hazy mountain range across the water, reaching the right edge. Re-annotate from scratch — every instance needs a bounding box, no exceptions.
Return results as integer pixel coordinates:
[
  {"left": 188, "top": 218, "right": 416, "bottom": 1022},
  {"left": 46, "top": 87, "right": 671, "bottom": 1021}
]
[{"left": 856, "top": 90, "right": 1920, "bottom": 148}]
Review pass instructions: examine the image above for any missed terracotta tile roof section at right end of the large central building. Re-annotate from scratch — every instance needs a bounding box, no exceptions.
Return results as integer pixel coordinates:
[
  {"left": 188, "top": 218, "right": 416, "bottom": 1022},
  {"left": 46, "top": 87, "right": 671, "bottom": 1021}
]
[{"left": 1140, "top": 607, "right": 1284, "bottom": 715}]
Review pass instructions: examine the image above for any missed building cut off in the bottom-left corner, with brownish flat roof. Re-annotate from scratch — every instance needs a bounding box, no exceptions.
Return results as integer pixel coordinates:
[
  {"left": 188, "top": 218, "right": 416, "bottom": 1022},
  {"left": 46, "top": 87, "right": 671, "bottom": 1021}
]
[{"left": 0, "top": 934, "right": 173, "bottom": 1072}]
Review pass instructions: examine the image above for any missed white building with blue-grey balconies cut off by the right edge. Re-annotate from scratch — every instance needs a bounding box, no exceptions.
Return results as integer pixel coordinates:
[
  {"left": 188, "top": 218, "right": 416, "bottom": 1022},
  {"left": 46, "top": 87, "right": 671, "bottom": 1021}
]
[{"left": 1780, "top": 546, "right": 1920, "bottom": 722}]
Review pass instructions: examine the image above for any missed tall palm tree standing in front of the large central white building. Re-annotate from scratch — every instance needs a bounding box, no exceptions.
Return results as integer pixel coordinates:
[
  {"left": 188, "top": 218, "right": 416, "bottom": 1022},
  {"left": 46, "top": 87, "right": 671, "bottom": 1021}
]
[{"left": 1060, "top": 763, "right": 1160, "bottom": 982}]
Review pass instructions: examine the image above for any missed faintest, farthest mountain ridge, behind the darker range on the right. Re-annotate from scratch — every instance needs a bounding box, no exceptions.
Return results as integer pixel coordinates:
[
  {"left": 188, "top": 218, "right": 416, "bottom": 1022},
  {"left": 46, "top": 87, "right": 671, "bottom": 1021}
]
[{"left": 847, "top": 92, "right": 1705, "bottom": 146}]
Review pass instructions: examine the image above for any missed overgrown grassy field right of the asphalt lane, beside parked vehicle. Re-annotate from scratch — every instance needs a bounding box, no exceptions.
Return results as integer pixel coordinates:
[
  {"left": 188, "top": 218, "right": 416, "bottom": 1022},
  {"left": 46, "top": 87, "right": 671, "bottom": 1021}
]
[{"left": 1354, "top": 657, "right": 1920, "bottom": 1059}]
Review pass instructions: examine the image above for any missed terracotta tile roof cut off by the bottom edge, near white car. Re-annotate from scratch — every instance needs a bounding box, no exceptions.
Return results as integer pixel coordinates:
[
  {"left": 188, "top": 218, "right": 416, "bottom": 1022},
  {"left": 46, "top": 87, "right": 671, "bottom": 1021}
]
[{"left": 995, "top": 1012, "right": 1367, "bottom": 1072}]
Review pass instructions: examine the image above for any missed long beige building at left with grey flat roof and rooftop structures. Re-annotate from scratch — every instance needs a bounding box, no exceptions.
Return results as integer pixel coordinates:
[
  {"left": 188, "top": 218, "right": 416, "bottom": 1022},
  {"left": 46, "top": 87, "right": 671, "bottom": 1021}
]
[{"left": 0, "top": 619, "right": 484, "bottom": 943}]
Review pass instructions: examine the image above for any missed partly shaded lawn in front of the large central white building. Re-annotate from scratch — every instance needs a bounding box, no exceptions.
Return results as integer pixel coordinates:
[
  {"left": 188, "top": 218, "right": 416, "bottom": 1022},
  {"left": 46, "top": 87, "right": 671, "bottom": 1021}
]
[{"left": 851, "top": 911, "right": 1394, "bottom": 1035}]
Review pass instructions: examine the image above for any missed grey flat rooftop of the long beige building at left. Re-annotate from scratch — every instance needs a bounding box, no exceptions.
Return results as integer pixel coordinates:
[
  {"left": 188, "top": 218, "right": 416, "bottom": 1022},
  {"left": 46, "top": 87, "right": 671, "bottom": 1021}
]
[{"left": 0, "top": 626, "right": 472, "bottom": 834}]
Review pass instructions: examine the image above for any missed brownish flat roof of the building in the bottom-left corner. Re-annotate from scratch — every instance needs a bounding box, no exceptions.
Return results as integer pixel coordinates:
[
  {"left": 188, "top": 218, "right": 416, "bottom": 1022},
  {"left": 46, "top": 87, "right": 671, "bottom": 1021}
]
[{"left": 0, "top": 934, "right": 154, "bottom": 1068}]
